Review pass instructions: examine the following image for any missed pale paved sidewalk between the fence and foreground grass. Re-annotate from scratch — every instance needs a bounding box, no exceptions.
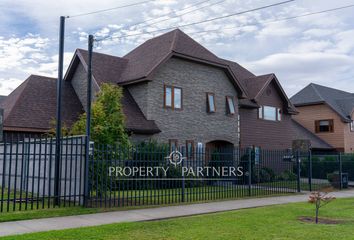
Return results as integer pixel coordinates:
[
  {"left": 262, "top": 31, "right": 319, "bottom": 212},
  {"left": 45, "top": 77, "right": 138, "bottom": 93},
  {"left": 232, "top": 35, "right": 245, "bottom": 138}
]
[{"left": 0, "top": 190, "right": 354, "bottom": 236}]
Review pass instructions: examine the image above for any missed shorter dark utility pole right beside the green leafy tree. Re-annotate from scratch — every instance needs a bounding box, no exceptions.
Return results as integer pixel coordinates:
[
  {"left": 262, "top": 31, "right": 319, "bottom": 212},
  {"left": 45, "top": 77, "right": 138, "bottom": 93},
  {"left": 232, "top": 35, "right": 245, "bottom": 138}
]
[{"left": 84, "top": 35, "right": 94, "bottom": 206}]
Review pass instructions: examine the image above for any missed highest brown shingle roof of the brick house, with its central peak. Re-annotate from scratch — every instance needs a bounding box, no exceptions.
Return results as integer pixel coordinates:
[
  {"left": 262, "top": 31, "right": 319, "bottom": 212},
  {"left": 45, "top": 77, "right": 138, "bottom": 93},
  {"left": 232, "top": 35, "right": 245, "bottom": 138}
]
[{"left": 65, "top": 29, "right": 249, "bottom": 97}]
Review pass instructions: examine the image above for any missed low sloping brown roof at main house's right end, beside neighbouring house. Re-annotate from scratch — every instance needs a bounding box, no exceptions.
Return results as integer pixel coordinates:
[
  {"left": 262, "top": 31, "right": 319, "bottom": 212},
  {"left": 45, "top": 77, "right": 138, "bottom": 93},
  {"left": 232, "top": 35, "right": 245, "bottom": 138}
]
[{"left": 292, "top": 119, "right": 334, "bottom": 149}]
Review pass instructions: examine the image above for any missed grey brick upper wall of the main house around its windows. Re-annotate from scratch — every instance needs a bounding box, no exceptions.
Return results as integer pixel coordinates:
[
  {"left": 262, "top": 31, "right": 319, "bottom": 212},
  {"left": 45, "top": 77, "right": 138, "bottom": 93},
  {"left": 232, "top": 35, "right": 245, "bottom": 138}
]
[{"left": 130, "top": 58, "right": 239, "bottom": 146}]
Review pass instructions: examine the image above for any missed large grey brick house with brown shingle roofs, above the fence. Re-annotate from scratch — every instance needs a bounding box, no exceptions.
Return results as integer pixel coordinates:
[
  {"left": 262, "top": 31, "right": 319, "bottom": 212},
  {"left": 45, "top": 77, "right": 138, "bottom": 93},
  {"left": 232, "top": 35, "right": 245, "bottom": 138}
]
[{"left": 1, "top": 29, "right": 328, "bottom": 149}]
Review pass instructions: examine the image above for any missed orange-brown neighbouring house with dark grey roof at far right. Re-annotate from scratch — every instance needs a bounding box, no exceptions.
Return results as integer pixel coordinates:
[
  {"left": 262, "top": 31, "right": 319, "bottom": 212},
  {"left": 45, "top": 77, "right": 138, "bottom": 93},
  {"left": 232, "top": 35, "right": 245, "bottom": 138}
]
[{"left": 291, "top": 83, "right": 354, "bottom": 152}]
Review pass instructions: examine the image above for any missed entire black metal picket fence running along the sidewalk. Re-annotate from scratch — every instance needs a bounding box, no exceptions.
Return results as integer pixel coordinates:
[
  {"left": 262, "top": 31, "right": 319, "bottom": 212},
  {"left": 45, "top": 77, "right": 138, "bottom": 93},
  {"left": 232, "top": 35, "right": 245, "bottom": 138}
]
[{"left": 0, "top": 135, "right": 354, "bottom": 212}]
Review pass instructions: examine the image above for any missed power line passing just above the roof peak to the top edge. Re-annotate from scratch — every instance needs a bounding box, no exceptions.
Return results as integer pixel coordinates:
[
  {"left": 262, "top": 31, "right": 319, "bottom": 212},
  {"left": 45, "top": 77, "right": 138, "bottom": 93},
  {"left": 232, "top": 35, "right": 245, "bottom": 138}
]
[{"left": 95, "top": 0, "right": 295, "bottom": 42}]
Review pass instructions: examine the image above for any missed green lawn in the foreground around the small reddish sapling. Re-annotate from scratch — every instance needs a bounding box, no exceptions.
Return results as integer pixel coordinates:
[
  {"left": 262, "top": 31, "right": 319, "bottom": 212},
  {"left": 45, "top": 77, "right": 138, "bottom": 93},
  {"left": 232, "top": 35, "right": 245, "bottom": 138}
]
[{"left": 1, "top": 198, "right": 354, "bottom": 240}]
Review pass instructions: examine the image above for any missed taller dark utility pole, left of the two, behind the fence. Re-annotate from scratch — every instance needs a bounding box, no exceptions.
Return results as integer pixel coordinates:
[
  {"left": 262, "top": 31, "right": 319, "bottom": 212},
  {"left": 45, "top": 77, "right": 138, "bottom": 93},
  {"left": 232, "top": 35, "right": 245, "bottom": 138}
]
[{"left": 54, "top": 16, "right": 65, "bottom": 205}]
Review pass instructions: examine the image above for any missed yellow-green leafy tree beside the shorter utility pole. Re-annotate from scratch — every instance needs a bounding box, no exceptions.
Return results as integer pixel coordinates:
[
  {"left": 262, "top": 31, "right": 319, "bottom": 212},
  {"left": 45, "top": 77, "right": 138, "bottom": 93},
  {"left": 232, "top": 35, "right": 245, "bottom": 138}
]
[{"left": 70, "top": 83, "right": 130, "bottom": 147}]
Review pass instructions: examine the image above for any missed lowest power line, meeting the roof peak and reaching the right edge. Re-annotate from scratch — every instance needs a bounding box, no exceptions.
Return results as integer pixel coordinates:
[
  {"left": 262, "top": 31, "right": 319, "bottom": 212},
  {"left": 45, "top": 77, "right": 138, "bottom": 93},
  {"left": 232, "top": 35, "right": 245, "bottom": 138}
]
[{"left": 97, "top": 4, "right": 354, "bottom": 41}]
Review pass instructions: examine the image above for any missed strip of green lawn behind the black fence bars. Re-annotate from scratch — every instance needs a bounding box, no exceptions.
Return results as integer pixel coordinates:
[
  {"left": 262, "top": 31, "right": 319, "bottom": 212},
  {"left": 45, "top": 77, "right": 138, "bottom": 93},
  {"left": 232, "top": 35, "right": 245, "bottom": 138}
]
[{"left": 90, "top": 184, "right": 294, "bottom": 207}]
